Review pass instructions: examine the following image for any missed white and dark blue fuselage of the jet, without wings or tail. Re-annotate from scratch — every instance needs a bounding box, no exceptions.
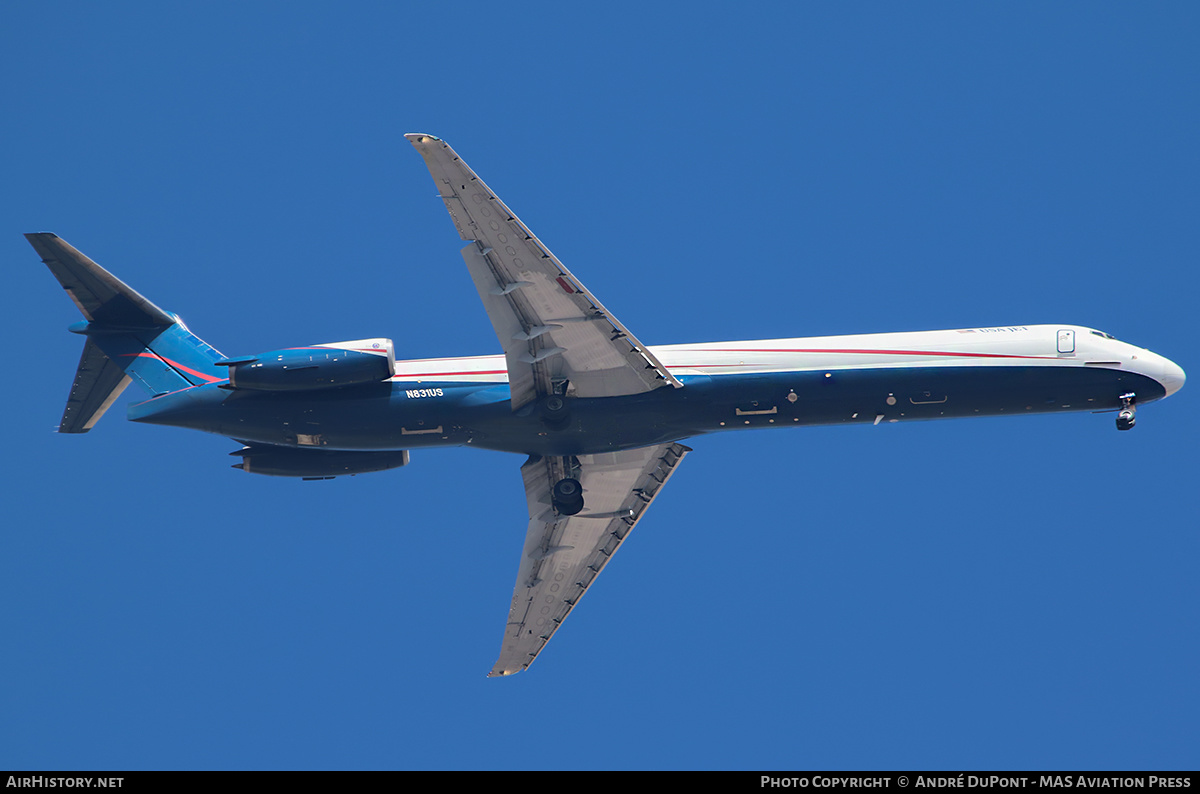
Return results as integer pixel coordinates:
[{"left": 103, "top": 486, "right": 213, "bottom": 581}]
[{"left": 130, "top": 325, "right": 1183, "bottom": 455}]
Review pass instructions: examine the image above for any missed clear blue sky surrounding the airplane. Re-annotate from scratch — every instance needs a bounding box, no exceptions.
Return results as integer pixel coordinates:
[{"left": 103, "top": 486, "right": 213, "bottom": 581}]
[{"left": 0, "top": 2, "right": 1200, "bottom": 770}]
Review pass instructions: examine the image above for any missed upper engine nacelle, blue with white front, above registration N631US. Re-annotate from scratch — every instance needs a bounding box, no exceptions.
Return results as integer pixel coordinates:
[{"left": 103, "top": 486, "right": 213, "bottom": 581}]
[{"left": 216, "top": 338, "right": 396, "bottom": 391}]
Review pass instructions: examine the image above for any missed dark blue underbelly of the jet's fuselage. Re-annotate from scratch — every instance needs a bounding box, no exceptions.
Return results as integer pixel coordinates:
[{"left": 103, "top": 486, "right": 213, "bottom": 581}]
[{"left": 130, "top": 366, "right": 1165, "bottom": 455}]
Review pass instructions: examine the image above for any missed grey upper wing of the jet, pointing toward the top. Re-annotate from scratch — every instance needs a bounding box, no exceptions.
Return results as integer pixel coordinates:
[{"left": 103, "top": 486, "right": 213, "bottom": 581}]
[{"left": 404, "top": 133, "right": 683, "bottom": 410}]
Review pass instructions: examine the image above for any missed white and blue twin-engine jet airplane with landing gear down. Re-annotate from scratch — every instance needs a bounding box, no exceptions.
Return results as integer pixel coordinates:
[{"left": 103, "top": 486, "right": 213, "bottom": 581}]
[{"left": 25, "top": 133, "right": 1186, "bottom": 676}]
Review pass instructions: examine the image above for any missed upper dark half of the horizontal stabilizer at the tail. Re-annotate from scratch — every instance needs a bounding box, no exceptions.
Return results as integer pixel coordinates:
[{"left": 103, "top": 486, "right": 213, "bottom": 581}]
[{"left": 25, "top": 231, "right": 175, "bottom": 329}]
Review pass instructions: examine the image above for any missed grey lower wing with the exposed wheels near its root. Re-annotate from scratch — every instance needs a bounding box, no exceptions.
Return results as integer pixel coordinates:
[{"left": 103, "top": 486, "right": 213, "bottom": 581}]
[{"left": 488, "top": 444, "right": 691, "bottom": 678}]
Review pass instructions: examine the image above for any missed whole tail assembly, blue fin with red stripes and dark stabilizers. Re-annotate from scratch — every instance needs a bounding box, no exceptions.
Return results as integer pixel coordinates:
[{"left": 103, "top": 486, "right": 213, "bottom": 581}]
[{"left": 25, "top": 233, "right": 228, "bottom": 433}]
